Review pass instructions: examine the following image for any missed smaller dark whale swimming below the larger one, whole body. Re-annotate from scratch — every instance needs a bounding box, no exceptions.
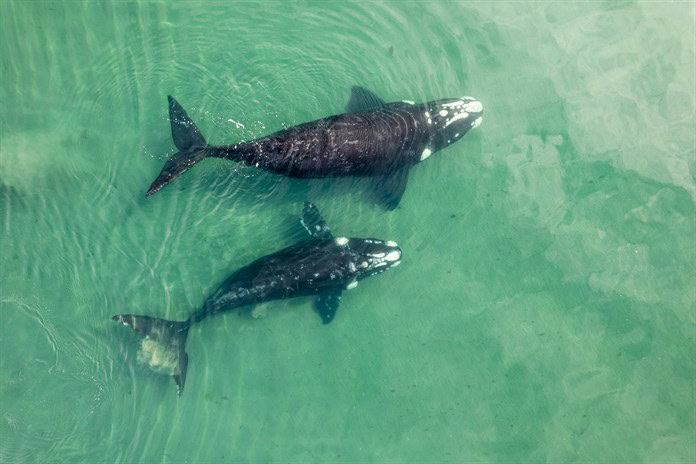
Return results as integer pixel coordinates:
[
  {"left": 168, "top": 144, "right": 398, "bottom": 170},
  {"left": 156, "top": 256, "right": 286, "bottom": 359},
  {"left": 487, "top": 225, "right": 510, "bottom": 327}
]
[{"left": 112, "top": 202, "right": 401, "bottom": 395}]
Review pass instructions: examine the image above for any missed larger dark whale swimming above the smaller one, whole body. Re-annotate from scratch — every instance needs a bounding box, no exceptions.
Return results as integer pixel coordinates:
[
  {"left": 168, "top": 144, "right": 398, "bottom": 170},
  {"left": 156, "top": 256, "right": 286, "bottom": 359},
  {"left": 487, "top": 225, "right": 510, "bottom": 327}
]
[{"left": 146, "top": 87, "right": 483, "bottom": 210}]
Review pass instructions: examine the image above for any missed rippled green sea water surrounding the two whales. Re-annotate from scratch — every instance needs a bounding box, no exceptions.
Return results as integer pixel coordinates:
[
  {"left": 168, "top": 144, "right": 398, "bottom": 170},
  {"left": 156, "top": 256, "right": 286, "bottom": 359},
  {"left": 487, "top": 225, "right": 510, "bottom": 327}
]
[{"left": 0, "top": 0, "right": 696, "bottom": 463}]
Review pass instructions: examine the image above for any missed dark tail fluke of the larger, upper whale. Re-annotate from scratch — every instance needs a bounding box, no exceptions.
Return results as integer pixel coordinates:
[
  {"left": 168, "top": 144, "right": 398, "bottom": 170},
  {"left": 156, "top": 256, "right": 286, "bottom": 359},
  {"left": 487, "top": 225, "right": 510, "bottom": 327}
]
[{"left": 145, "top": 95, "right": 208, "bottom": 196}]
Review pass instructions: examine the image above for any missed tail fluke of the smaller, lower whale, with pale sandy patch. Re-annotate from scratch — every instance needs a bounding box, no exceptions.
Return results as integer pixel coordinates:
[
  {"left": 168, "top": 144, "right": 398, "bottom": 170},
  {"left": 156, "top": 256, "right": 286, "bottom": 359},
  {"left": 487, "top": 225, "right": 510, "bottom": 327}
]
[{"left": 112, "top": 314, "right": 191, "bottom": 396}]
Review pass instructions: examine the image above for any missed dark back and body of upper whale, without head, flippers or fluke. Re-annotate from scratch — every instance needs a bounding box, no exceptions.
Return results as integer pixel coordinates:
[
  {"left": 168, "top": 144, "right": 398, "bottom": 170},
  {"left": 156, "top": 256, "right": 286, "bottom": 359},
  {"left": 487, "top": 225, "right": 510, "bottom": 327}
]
[{"left": 208, "top": 102, "right": 432, "bottom": 178}]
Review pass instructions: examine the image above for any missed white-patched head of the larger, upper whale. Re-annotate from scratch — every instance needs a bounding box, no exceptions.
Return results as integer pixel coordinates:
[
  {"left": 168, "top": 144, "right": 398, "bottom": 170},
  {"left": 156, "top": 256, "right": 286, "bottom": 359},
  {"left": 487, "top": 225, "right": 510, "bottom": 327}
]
[{"left": 421, "top": 97, "right": 483, "bottom": 160}]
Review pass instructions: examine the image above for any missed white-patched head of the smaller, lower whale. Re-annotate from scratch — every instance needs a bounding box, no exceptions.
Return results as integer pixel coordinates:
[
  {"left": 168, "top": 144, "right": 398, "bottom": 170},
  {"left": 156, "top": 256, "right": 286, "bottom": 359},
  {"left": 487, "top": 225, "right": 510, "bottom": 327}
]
[{"left": 335, "top": 237, "right": 401, "bottom": 280}]
